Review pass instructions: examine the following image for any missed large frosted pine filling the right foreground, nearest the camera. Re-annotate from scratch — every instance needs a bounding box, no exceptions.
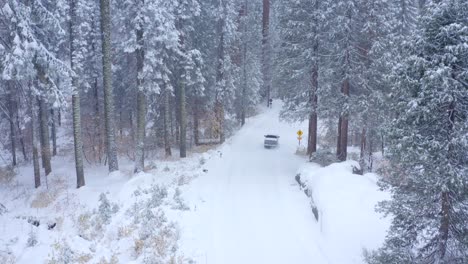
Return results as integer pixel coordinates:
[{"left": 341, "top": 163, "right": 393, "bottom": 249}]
[{"left": 367, "top": 0, "right": 468, "bottom": 264}]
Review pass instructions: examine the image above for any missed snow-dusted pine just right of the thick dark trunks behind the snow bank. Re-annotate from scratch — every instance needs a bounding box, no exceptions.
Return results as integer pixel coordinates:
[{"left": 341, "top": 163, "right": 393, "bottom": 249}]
[{"left": 352, "top": 0, "right": 397, "bottom": 172}]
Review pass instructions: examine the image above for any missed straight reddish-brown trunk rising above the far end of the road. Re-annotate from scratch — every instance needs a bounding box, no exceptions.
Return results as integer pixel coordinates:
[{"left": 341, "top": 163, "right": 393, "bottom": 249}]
[{"left": 262, "top": 0, "right": 271, "bottom": 106}]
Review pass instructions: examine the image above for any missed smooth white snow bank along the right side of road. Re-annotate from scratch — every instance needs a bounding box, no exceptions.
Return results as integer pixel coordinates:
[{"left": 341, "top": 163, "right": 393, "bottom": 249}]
[{"left": 298, "top": 161, "right": 390, "bottom": 264}]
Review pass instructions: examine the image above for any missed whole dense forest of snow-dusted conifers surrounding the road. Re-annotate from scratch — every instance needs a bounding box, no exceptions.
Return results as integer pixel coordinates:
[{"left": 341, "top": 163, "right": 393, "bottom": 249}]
[{"left": 0, "top": 0, "right": 468, "bottom": 264}]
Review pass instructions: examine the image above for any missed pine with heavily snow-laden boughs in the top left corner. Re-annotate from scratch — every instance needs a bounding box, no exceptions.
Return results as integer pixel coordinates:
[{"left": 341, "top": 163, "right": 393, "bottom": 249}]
[{"left": 1, "top": 0, "right": 70, "bottom": 175}]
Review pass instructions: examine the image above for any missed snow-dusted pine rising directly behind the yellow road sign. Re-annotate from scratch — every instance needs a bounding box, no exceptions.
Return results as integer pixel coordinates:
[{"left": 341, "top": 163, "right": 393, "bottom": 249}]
[{"left": 279, "top": 0, "right": 327, "bottom": 155}]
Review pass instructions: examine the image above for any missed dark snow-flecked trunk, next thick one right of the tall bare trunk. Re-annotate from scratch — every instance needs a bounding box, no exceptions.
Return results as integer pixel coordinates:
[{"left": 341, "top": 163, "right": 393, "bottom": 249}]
[{"left": 134, "top": 24, "right": 146, "bottom": 173}]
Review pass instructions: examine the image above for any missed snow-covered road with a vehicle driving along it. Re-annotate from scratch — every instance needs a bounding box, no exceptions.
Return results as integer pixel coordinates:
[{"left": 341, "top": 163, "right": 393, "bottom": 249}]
[{"left": 183, "top": 103, "right": 328, "bottom": 264}]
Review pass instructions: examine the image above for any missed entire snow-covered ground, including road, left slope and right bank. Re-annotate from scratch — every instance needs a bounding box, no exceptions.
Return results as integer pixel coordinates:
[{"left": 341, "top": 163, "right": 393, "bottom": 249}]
[{"left": 0, "top": 102, "right": 389, "bottom": 264}]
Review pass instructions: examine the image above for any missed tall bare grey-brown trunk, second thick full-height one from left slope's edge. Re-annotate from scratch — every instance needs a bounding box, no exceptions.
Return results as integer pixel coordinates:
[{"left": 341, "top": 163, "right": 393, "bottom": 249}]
[{"left": 100, "top": 0, "right": 119, "bottom": 172}]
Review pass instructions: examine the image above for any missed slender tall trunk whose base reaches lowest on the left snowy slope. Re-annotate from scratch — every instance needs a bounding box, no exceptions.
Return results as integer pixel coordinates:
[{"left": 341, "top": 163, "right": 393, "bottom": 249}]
[{"left": 69, "top": 0, "right": 85, "bottom": 188}]
